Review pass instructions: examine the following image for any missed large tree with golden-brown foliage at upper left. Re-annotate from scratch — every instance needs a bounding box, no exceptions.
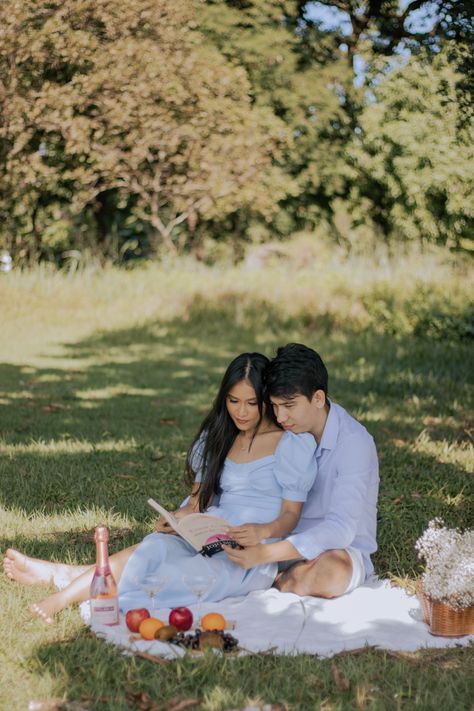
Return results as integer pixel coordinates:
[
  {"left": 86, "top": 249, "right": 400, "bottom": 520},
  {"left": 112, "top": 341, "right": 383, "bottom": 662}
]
[{"left": 0, "top": 0, "right": 285, "bottom": 256}]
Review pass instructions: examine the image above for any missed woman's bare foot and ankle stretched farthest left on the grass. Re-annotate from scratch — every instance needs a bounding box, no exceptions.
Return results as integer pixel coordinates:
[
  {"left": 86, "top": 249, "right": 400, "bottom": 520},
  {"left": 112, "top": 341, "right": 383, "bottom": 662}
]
[{"left": 3, "top": 548, "right": 89, "bottom": 588}]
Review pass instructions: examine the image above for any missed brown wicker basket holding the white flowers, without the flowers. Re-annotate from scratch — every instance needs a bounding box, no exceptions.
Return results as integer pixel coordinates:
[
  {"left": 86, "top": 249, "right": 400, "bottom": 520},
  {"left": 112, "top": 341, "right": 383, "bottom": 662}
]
[{"left": 416, "top": 580, "right": 474, "bottom": 637}]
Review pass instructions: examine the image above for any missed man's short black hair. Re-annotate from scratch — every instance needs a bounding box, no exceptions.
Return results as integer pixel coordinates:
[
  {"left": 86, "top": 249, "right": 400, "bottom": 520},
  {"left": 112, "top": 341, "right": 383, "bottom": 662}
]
[{"left": 265, "top": 343, "right": 328, "bottom": 400}]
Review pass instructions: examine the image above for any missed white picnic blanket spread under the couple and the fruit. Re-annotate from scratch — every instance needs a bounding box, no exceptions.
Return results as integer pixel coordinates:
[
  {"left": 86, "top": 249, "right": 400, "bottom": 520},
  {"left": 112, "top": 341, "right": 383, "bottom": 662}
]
[{"left": 81, "top": 579, "right": 474, "bottom": 658}]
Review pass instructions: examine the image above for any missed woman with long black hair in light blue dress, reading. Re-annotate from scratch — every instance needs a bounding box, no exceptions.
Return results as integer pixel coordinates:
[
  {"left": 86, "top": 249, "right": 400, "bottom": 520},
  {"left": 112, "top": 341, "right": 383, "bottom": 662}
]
[{"left": 3, "top": 353, "right": 316, "bottom": 623}]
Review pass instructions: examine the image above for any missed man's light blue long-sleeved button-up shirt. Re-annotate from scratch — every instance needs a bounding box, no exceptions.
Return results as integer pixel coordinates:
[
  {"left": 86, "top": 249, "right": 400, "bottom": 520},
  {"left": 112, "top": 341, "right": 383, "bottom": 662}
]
[{"left": 287, "top": 402, "right": 379, "bottom": 575}]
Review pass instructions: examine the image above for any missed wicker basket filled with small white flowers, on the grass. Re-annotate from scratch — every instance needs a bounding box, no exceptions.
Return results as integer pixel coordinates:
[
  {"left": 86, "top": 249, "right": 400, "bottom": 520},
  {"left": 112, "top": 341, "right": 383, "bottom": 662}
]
[{"left": 415, "top": 518, "right": 474, "bottom": 637}]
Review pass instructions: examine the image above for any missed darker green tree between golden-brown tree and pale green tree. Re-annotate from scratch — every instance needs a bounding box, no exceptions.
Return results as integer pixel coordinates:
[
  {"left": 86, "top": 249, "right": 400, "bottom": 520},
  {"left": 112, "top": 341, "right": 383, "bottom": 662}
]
[{"left": 198, "top": 0, "right": 361, "bottom": 238}]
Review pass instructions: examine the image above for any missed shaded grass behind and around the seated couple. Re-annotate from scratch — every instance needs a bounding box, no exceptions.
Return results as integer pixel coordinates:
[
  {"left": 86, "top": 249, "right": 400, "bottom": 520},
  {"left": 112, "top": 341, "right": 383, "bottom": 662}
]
[{"left": 0, "top": 299, "right": 473, "bottom": 574}]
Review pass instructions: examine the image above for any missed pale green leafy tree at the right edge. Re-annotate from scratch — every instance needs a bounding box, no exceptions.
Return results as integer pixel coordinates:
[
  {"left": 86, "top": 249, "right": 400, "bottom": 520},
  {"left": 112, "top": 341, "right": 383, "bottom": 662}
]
[{"left": 351, "top": 51, "right": 474, "bottom": 248}]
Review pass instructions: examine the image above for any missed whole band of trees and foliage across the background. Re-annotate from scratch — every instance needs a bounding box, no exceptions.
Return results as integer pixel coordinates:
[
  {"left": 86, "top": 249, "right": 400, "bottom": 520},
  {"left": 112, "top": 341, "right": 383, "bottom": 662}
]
[{"left": 0, "top": 0, "right": 473, "bottom": 265}]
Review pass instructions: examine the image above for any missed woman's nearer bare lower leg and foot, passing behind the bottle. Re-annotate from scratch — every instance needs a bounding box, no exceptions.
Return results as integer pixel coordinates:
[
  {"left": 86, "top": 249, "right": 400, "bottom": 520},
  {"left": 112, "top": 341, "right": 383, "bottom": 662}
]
[{"left": 30, "top": 545, "right": 136, "bottom": 624}]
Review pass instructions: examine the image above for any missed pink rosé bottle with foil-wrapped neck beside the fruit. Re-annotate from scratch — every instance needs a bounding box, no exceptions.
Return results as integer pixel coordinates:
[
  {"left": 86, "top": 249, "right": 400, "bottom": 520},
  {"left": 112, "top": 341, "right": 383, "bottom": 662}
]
[{"left": 89, "top": 526, "right": 119, "bottom": 625}]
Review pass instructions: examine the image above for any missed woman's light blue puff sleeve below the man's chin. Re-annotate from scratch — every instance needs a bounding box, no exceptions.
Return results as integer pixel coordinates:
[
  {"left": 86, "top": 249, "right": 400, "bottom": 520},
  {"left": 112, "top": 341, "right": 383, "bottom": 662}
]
[{"left": 274, "top": 432, "right": 317, "bottom": 501}]
